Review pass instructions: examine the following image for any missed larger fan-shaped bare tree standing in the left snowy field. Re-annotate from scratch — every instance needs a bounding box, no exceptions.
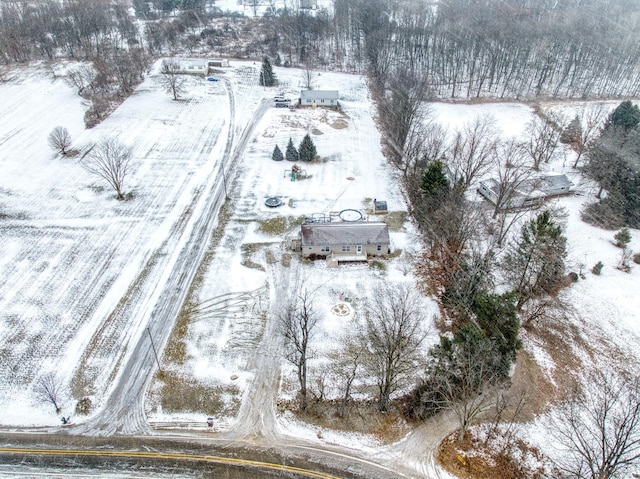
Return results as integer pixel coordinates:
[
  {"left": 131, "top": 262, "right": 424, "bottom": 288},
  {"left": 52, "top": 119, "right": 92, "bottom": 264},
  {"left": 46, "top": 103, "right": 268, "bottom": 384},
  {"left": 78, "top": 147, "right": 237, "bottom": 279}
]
[{"left": 84, "top": 138, "right": 132, "bottom": 200}]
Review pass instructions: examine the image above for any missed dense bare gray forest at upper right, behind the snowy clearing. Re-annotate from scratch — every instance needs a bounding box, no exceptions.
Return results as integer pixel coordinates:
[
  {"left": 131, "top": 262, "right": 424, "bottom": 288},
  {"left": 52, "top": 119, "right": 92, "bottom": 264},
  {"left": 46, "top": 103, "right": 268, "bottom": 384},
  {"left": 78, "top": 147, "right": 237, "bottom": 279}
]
[{"left": 348, "top": 0, "right": 640, "bottom": 99}]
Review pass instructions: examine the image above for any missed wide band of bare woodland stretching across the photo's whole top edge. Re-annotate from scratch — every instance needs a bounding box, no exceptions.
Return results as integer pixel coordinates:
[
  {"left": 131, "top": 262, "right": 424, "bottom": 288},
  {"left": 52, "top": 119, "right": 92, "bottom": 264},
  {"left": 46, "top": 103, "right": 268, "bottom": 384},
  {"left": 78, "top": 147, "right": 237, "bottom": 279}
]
[{"left": 8, "top": 0, "right": 640, "bottom": 102}]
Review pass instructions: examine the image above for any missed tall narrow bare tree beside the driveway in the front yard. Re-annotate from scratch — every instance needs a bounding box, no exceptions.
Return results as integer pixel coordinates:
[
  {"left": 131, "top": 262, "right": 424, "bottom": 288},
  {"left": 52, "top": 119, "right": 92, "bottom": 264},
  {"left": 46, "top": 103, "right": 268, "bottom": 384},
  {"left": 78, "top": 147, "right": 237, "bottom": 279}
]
[{"left": 278, "top": 285, "right": 319, "bottom": 410}]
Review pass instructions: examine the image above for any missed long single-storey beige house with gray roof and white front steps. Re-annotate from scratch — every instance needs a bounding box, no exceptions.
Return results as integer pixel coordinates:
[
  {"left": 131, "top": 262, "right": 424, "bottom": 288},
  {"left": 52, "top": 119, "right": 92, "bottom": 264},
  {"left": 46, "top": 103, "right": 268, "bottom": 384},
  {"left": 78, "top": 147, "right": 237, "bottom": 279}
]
[{"left": 300, "top": 221, "right": 390, "bottom": 266}]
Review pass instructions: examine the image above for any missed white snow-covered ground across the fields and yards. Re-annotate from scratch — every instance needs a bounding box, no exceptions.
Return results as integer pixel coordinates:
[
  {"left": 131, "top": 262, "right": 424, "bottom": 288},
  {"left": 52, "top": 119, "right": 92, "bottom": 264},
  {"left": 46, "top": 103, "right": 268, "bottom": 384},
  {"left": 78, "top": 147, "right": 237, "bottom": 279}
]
[{"left": 0, "top": 58, "right": 640, "bottom": 474}]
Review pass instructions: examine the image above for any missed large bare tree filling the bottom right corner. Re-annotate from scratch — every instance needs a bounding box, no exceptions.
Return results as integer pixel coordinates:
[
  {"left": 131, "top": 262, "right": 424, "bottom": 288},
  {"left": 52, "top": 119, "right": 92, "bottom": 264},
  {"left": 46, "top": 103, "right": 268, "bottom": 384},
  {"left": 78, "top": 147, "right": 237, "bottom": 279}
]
[{"left": 551, "top": 371, "right": 640, "bottom": 479}]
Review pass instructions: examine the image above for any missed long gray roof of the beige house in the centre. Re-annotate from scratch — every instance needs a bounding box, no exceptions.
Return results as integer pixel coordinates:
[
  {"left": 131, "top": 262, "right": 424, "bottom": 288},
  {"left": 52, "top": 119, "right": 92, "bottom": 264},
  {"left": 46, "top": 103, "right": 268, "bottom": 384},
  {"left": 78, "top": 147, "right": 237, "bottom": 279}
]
[{"left": 301, "top": 221, "right": 389, "bottom": 246}]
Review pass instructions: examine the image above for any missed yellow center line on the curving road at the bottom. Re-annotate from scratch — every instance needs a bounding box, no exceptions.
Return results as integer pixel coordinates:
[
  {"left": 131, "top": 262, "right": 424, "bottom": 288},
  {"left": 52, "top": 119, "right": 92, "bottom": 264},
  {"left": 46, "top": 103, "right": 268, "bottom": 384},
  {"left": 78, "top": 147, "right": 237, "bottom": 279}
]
[{"left": 0, "top": 447, "right": 342, "bottom": 479}]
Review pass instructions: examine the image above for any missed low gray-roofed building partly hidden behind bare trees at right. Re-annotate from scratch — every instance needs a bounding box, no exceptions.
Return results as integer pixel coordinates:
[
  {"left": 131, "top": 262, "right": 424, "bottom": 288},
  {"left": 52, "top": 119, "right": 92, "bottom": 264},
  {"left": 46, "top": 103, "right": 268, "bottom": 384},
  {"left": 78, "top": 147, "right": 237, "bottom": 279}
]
[{"left": 478, "top": 175, "right": 573, "bottom": 209}]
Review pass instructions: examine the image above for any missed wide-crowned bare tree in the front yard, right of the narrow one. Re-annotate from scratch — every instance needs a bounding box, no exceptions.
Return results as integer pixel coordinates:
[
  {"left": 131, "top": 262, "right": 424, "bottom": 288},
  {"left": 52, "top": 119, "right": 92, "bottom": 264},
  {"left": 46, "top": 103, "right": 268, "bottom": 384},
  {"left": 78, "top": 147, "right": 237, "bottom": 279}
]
[{"left": 362, "top": 285, "right": 427, "bottom": 411}]
